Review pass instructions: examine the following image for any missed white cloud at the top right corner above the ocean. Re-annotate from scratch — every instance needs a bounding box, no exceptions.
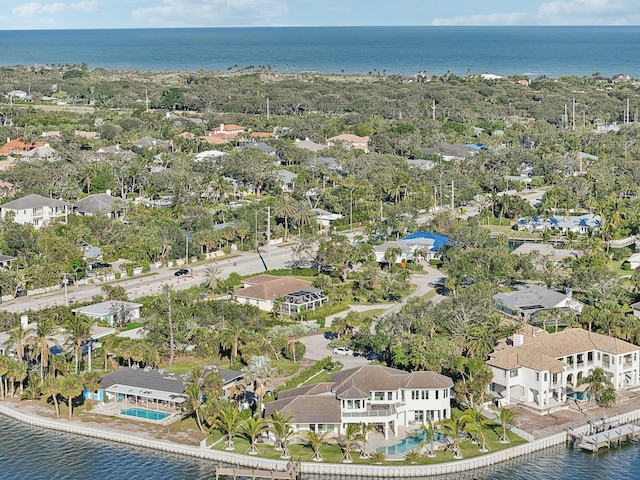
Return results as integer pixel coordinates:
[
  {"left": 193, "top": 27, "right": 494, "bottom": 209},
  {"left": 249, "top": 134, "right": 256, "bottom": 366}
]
[{"left": 432, "top": 0, "right": 640, "bottom": 26}]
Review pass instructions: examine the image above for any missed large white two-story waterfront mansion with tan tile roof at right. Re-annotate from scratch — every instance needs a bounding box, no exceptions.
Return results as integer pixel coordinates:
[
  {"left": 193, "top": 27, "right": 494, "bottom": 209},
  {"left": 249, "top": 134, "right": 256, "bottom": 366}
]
[{"left": 487, "top": 326, "right": 640, "bottom": 414}]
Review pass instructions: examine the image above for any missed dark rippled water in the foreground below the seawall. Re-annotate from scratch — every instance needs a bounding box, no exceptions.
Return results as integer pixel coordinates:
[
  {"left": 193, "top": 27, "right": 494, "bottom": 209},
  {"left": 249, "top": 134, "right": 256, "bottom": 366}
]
[{"left": 0, "top": 416, "right": 640, "bottom": 480}]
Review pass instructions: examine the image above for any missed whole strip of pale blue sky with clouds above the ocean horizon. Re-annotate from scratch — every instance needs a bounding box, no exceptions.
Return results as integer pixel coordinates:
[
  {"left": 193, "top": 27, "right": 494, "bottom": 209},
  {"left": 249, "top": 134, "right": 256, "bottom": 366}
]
[{"left": 5, "top": 0, "right": 640, "bottom": 30}]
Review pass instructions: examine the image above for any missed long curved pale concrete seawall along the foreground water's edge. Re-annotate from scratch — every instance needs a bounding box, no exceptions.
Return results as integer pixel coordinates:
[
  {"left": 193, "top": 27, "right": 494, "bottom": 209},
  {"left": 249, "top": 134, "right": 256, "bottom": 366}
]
[{"left": 0, "top": 403, "right": 640, "bottom": 478}]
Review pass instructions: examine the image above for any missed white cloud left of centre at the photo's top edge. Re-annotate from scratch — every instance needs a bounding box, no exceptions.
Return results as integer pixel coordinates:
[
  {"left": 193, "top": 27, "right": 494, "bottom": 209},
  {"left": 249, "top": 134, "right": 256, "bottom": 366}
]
[{"left": 131, "top": 0, "right": 287, "bottom": 27}]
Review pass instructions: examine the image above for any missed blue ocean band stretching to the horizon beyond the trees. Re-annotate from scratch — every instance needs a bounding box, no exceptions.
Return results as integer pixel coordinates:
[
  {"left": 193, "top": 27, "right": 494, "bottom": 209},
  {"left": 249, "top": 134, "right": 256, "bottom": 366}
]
[{"left": 0, "top": 26, "right": 640, "bottom": 78}]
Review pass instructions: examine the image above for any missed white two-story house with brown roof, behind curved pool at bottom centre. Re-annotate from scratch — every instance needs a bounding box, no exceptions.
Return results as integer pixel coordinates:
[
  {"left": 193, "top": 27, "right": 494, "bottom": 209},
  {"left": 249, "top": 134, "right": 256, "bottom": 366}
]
[{"left": 265, "top": 365, "right": 453, "bottom": 438}]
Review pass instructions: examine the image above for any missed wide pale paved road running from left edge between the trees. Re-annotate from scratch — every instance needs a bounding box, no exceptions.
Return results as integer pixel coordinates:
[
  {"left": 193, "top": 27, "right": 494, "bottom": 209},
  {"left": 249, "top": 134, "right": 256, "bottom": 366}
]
[{"left": 0, "top": 247, "right": 291, "bottom": 312}]
